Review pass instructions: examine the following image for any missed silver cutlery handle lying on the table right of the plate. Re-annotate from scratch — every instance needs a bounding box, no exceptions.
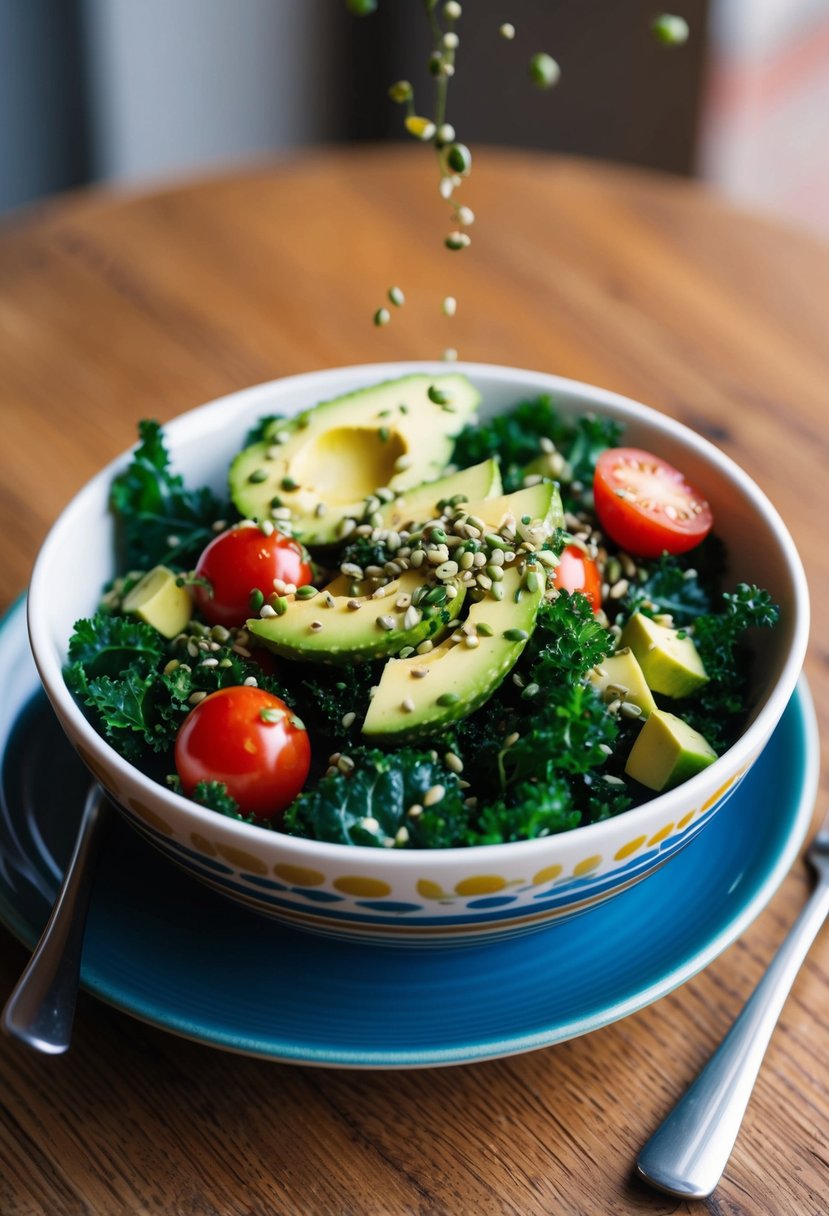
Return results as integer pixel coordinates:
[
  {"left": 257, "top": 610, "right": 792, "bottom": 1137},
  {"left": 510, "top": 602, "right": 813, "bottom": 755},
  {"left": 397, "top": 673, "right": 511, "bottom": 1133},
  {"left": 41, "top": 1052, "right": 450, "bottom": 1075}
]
[{"left": 636, "top": 872, "right": 829, "bottom": 1199}]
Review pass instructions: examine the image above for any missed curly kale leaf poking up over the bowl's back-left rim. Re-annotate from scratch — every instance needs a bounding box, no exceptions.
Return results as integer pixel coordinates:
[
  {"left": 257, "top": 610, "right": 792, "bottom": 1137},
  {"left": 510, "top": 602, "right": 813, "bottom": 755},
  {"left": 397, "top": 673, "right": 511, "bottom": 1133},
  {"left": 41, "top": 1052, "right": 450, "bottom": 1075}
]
[{"left": 109, "top": 421, "right": 236, "bottom": 570}]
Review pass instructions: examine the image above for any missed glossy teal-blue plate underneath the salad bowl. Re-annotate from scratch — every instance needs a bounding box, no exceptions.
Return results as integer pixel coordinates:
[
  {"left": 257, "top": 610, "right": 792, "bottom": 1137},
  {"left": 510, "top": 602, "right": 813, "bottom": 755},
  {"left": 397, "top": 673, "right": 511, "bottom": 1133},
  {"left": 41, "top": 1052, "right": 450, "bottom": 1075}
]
[{"left": 0, "top": 603, "right": 818, "bottom": 1068}]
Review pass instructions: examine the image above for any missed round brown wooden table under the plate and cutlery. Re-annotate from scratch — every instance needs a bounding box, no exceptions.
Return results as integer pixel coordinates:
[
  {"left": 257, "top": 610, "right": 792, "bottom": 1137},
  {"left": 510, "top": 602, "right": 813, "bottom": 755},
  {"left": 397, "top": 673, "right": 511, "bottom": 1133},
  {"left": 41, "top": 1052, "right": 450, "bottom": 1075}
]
[{"left": 0, "top": 150, "right": 829, "bottom": 1216}]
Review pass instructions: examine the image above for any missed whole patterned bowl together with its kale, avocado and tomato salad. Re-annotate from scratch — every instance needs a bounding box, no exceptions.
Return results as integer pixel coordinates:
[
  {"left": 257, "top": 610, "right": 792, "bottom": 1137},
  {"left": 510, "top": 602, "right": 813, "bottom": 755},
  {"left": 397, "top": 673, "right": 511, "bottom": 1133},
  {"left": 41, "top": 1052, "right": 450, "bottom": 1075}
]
[{"left": 29, "top": 364, "right": 808, "bottom": 941}]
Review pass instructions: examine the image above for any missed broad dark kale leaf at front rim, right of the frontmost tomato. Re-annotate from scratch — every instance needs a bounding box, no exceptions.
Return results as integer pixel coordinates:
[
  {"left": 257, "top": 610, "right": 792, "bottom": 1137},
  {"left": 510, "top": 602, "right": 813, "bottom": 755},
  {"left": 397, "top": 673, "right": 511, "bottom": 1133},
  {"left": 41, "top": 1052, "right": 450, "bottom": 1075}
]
[{"left": 283, "top": 748, "right": 469, "bottom": 849}]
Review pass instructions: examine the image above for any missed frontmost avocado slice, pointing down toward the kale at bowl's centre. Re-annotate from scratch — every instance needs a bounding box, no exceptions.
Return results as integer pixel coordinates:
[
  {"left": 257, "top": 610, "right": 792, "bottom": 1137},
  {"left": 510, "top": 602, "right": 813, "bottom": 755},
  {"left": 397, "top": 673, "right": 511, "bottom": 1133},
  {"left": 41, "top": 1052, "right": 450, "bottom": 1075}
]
[{"left": 362, "top": 568, "right": 543, "bottom": 743}]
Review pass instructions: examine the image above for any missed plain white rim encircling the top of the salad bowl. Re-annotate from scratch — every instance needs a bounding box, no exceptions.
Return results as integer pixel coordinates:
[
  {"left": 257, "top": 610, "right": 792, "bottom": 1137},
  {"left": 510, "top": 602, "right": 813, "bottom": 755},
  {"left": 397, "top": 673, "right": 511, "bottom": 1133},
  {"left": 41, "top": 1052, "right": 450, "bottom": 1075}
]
[{"left": 27, "top": 360, "right": 810, "bottom": 869}]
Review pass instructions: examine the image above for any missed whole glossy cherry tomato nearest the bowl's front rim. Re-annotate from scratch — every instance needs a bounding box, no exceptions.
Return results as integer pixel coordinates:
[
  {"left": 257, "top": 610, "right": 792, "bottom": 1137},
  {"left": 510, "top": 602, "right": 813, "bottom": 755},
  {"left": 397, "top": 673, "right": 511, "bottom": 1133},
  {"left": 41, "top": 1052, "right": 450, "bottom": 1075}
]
[{"left": 175, "top": 685, "right": 311, "bottom": 820}]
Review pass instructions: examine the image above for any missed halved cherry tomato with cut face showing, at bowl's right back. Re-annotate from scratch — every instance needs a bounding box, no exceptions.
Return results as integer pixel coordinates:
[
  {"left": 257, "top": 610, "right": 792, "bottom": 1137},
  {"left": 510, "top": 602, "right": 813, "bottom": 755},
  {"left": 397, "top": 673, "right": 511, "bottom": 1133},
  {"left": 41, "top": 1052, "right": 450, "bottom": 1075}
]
[{"left": 593, "top": 447, "right": 714, "bottom": 557}]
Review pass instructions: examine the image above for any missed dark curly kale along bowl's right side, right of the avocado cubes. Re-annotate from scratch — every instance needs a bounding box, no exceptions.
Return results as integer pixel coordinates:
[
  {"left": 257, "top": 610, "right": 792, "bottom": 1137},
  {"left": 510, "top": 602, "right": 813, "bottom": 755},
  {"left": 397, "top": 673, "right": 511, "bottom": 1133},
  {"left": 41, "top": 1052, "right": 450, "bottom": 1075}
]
[{"left": 682, "top": 582, "right": 780, "bottom": 754}]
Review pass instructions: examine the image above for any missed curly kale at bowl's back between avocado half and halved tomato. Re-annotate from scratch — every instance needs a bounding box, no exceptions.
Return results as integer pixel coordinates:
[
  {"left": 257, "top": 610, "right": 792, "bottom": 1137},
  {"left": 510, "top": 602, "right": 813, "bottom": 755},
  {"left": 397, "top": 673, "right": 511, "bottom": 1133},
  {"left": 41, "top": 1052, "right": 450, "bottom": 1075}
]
[{"left": 452, "top": 396, "right": 621, "bottom": 507}]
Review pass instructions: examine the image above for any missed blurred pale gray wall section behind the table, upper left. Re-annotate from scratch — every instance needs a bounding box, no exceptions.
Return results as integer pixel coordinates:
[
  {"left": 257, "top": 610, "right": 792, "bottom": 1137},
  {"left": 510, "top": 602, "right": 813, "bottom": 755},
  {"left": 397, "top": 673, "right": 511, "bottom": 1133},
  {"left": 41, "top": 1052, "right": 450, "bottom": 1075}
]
[{"left": 84, "top": 0, "right": 348, "bottom": 181}]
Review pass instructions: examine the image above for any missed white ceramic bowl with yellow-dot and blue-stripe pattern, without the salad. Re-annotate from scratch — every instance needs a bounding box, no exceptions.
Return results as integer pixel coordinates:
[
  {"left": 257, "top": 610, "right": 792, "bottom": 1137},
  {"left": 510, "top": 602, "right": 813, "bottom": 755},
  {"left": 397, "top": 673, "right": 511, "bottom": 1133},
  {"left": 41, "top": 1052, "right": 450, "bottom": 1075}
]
[{"left": 28, "top": 364, "right": 808, "bottom": 944}]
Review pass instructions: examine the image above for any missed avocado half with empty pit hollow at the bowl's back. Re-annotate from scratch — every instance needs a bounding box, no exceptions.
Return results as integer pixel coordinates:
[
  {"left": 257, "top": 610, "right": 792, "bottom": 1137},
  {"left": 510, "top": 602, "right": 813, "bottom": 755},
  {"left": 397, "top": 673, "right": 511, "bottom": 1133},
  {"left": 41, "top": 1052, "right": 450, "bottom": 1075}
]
[{"left": 230, "top": 373, "right": 480, "bottom": 545}]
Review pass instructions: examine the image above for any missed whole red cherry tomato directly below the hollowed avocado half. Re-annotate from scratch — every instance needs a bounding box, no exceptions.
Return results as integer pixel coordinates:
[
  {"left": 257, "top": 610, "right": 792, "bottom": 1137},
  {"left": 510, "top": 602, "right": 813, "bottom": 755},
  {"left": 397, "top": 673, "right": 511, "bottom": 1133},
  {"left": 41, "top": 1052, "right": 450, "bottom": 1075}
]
[{"left": 194, "top": 524, "right": 311, "bottom": 626}]
